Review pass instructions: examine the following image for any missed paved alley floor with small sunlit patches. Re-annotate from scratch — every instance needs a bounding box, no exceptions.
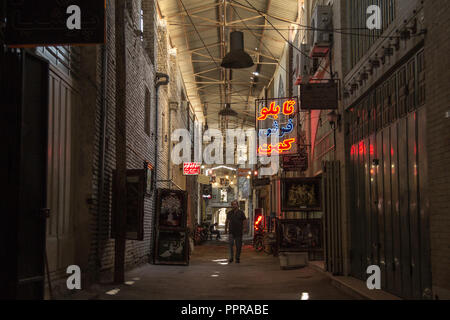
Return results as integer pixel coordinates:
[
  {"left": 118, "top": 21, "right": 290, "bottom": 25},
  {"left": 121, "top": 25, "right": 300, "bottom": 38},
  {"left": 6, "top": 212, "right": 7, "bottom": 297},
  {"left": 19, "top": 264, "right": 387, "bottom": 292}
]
[{"left": 98, "top": 241, "right": 352, "bottom": 300}]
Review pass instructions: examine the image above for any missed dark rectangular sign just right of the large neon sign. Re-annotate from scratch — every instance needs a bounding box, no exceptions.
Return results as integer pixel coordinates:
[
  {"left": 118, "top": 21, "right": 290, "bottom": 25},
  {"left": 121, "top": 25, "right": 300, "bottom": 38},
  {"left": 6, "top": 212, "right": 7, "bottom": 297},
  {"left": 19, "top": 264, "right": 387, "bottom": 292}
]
[{"left": 300, "top": 81, "right": 338, "bottom": 110}]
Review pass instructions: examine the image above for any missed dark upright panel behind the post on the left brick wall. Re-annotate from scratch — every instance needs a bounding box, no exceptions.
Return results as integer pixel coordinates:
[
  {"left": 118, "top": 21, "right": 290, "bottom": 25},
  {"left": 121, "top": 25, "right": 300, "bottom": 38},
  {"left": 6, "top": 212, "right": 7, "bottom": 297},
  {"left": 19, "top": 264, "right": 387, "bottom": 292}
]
[{"left": 111, "top": 169, "right": 146, "bottom": 241}]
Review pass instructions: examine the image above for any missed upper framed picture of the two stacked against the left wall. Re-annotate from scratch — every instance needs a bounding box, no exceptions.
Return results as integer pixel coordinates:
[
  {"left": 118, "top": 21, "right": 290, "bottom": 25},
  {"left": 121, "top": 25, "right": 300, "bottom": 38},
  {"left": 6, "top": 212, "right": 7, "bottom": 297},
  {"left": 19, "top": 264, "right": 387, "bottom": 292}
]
[{"left": 156, "top": 189, "right": 187, "bottom": 229}]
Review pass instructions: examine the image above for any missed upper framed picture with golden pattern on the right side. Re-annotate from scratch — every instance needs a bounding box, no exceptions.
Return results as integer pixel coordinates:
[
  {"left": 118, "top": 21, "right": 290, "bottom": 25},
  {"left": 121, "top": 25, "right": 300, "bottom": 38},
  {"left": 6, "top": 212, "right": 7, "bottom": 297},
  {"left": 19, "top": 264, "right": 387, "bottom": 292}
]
[{"left": 281, "top": 177, "right": 322, "bottom": 212}]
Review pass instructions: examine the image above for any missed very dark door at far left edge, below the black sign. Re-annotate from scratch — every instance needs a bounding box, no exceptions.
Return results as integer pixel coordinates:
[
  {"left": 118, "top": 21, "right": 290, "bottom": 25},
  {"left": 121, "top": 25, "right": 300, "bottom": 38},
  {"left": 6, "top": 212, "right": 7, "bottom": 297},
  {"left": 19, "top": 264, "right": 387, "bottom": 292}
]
[{"left": 0, "top": 50, "right": 49, "bottom": 299}]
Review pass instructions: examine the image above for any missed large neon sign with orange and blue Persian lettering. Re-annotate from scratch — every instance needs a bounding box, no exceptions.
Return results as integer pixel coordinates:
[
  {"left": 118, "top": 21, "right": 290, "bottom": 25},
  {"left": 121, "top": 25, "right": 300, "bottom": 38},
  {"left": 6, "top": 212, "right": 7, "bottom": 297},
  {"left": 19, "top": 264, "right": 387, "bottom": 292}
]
[{"left": 255, "top": 98, "right": 299, "bottom": 156}]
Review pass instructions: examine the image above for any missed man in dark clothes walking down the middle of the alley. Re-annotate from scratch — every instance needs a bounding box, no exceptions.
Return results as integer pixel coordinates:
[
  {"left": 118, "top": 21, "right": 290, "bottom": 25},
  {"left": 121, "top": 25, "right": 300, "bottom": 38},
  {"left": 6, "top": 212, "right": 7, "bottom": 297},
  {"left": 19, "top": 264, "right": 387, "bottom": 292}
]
[{"left": 225, "top": 200, "right": 248, "bottom": 263}]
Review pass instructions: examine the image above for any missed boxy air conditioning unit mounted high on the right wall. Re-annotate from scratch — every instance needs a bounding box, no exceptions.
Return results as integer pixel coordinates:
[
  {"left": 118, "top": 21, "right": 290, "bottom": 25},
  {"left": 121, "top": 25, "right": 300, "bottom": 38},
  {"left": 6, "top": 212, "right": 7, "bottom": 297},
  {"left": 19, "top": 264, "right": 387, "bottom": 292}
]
[{"left": 311, "top": 5, "right": 333, "bottom": 58}]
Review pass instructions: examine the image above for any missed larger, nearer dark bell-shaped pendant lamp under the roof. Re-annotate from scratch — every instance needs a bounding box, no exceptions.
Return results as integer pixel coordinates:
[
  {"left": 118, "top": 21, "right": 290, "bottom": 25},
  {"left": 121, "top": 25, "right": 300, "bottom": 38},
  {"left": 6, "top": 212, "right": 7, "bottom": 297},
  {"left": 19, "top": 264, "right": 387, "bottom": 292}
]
[{"left": 221, "top": 31, "right": 254, "bottom": 69}]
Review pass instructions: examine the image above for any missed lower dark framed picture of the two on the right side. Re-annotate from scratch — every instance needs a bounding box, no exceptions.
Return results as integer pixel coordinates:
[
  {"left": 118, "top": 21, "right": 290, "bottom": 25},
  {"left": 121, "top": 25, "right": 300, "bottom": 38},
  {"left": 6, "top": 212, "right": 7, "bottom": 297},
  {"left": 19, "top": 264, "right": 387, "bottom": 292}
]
[{"left": 277, "top": 219, "right": 323, "bottom": 252}]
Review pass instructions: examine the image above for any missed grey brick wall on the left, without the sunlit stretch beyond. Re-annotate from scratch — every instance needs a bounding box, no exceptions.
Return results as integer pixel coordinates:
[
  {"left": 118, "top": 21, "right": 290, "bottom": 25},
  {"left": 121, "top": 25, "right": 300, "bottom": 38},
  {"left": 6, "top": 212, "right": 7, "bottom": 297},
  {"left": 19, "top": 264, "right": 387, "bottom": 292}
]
[{"left": 90, "top": 1, "right": 157, "bottom": 280}]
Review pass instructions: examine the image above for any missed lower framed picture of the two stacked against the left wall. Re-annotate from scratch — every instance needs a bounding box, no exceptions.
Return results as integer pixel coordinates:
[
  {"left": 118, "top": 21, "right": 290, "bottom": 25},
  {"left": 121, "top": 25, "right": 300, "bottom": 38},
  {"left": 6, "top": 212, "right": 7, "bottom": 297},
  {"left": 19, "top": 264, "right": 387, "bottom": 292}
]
[{"left": 155, "top": 230, "right": 189, "bottom": 265}]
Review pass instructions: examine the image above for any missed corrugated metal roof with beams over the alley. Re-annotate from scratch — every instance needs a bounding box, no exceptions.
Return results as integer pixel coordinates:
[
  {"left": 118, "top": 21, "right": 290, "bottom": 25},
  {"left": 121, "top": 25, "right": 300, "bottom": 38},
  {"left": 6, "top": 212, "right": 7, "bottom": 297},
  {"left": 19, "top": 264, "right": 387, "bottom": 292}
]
[{"left": 158, "top": 0, "right": 297, "bottom": 127}]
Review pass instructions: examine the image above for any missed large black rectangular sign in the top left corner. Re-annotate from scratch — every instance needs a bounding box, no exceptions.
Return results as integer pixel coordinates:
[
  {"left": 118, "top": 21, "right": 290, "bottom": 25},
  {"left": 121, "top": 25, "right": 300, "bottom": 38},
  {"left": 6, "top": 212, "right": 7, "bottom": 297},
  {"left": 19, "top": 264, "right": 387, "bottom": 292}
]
[{"left": 5, "top": 0, "right": 105, "bottom": 47}]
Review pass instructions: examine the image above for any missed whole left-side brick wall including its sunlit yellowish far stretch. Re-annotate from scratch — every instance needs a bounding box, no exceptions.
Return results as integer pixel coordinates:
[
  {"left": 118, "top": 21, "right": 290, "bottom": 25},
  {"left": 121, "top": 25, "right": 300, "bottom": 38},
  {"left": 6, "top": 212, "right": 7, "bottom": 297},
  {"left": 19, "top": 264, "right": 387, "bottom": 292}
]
[{"left": 85, "top": 1, "right": 194, "bottom": 281}]
